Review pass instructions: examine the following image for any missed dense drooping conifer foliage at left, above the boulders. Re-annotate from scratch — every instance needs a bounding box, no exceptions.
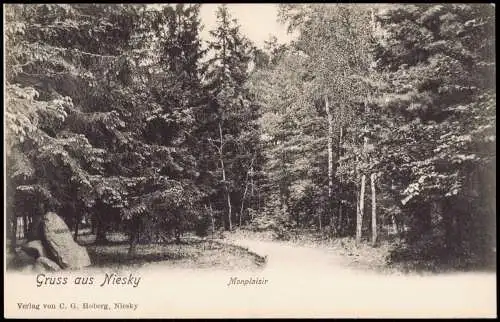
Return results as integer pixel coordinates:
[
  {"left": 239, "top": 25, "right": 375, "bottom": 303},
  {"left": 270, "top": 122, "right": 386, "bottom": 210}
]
[{"left": 7, "top": 5, "right": 205, "bottom": 247}]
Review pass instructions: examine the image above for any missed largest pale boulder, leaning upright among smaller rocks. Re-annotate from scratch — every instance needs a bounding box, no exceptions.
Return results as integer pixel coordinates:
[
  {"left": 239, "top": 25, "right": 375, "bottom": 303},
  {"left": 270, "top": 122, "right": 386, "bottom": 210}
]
[{"left": 43, "top": 212, "right": 91, "bottom": 269}]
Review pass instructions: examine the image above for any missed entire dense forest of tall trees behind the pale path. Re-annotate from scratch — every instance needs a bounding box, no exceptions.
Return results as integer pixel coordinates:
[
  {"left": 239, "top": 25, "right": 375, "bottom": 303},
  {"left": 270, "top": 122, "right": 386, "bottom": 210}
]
[{"left": 4, "top": 4, "right": 496, "bottom": 265}]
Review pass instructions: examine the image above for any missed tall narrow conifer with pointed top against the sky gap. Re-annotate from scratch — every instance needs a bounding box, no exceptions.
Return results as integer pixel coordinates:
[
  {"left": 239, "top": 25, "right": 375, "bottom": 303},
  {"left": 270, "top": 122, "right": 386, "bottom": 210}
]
[{"left": 197, "top": 5, "right": 259, "bottom": 228}]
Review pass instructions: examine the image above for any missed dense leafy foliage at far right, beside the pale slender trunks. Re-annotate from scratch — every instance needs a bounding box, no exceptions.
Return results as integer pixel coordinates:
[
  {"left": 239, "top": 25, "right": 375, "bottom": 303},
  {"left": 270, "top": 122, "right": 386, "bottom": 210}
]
[{"left": 371, "top": 5, "right": 496, "bottom": 262}]
